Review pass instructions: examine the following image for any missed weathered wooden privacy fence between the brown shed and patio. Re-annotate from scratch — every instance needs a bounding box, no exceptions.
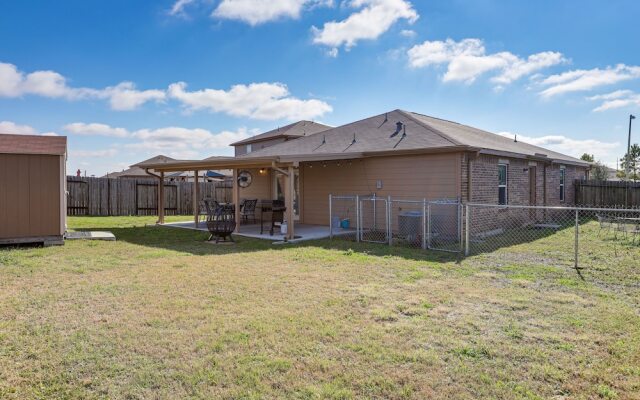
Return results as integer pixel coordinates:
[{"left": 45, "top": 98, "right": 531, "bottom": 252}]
[{"left": 67, "top": 176, "right": 232, "bottom": 216}]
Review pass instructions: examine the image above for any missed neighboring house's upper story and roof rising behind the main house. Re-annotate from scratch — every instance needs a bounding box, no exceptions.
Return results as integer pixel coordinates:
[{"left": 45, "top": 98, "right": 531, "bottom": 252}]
[{"left": 231, "top": 121, "right": 331, "bottom": 156}]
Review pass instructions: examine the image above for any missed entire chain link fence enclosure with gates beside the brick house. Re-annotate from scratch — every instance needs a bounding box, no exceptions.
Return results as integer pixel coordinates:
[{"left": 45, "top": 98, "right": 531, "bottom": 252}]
[{"left": 329, "top": 195, "right": 640, "bottom": 268}]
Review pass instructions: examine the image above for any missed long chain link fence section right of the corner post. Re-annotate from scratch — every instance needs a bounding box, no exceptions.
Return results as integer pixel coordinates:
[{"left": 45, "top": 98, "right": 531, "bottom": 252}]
[{"left": 464, "top": 204, "right": 640, "bottom": 268}]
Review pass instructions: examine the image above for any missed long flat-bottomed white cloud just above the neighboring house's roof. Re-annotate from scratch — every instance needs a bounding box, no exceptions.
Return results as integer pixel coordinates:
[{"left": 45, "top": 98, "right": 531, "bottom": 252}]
[{"left": 168, "top": 82, "right": 332, "bottom": 120}]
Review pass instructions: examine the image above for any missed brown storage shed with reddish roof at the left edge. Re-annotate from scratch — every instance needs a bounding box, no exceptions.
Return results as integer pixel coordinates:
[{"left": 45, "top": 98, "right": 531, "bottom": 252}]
[{"left": 0, "top": 134, "right": 67, "bottom": 245}]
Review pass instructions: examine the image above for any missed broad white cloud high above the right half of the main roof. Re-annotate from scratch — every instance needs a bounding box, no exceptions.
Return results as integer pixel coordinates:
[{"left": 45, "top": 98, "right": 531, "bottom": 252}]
[{"left": 407, "top": 39, "right": 566, "bottom": 85}]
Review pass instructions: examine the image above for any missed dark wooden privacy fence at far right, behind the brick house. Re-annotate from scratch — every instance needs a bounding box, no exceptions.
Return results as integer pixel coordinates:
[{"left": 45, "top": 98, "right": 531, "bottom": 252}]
[{"left": 575, "top": 180, "right": 640, "bottom": 208}]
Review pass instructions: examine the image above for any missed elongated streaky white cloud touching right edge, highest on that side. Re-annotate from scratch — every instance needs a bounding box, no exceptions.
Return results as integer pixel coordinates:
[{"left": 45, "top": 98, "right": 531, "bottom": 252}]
[{"left": 540, "top": 64, "right": 640, "bottom": 97}]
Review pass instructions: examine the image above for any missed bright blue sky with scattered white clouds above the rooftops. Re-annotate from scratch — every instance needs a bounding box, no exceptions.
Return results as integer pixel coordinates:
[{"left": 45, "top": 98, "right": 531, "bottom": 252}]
[{"left": 0, "top": 0, "right": 640, "bottom": 175}]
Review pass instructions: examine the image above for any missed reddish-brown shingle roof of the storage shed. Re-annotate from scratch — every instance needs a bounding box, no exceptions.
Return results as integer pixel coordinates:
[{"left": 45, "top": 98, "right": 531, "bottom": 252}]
[{"left": 0, "top": 133, "right": 67, "bottom": 156}]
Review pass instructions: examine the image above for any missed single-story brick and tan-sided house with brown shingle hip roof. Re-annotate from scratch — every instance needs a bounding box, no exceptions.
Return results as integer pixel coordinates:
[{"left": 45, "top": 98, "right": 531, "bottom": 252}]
[{"left": 140, "top": 110, "right": 590, "bottom": 237}]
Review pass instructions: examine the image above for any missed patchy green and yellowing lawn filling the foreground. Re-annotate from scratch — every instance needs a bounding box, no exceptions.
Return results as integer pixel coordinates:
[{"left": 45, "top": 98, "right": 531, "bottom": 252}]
[{"left": 0, "top": 217, "right": 640, "bottom": 399}]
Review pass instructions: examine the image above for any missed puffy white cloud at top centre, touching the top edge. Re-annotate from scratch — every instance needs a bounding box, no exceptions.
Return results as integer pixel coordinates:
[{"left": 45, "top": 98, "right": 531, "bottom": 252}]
[{"left": 312, "top": 0, "right": 419, "bottom": 49}]
